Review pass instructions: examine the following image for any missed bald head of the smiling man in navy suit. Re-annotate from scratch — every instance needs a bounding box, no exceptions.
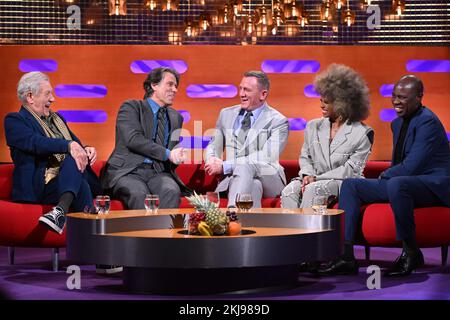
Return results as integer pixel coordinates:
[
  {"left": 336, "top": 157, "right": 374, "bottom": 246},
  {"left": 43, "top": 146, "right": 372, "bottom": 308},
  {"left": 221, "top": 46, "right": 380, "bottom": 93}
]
[{"left": 392, "top": 75, "right": 423, "bottom": 118}]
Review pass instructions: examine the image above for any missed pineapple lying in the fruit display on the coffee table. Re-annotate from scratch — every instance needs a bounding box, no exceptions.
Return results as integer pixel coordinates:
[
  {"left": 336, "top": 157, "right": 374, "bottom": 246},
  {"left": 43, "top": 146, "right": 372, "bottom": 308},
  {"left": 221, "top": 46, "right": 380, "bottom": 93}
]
[{"left": 186, "top": 191, "right": 227, "bottom": 235}]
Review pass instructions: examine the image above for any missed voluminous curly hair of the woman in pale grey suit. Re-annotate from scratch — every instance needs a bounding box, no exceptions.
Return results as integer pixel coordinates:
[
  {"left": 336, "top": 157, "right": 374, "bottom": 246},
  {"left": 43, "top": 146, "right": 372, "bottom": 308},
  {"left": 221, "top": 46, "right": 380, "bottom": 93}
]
[{"left": 314, "top": 63, "right": 370, "bottom": 122}]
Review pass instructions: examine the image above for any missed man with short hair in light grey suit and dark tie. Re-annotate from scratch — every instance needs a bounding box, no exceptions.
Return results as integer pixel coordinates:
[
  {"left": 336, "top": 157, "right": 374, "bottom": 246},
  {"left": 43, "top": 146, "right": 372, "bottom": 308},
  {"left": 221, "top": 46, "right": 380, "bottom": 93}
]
[{"left": 205, "top": 71, "right": 289, "bottom": 208}]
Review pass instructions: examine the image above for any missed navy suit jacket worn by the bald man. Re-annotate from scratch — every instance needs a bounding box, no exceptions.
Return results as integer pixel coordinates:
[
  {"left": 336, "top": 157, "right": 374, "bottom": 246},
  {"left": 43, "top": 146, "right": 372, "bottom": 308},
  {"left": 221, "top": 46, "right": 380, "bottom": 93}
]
[{"left": 380, "top": 107, "right": 450, "bottom": 206}]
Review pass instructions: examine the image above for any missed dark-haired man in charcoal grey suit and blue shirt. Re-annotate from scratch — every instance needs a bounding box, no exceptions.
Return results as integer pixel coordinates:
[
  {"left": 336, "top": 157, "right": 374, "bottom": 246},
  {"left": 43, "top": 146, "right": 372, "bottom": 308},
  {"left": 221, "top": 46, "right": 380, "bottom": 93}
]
[{"left": 102, "top": 68, "right": 187, "bottom": 209}]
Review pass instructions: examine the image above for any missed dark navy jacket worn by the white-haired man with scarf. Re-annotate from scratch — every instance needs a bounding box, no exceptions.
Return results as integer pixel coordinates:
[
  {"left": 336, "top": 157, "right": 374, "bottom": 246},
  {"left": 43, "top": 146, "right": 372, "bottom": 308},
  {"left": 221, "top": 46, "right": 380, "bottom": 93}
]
[{"left": 5, "top": 107, "right": 95, "bottom": 203}]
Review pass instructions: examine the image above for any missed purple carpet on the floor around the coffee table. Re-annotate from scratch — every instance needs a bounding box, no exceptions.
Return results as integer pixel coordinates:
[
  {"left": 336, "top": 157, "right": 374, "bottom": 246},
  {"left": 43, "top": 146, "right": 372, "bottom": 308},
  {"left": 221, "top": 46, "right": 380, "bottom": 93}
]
[{"left": 0, "top": 247, "right": 450, "bottom": 300}]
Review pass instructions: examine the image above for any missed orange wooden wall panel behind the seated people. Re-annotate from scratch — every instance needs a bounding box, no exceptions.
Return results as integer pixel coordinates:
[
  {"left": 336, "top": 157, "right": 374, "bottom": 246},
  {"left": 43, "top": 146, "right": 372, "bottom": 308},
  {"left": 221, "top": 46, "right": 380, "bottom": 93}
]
[{"left": 0, "top": 45, "right": 450, "bottom": 162}]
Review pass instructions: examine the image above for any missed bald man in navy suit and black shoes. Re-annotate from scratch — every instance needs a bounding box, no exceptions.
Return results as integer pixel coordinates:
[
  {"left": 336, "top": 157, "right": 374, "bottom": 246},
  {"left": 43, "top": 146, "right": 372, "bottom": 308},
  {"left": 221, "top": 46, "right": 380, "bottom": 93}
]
[{"left": 319, "top": 75, "right": 450, "bottom": 276}]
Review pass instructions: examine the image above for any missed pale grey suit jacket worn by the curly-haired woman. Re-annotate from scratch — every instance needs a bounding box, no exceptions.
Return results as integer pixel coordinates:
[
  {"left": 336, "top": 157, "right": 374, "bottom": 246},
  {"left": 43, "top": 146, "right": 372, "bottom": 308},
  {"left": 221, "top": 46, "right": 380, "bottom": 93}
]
[{"left": 299, "top": 118, "right": 373, "bottom": 180}]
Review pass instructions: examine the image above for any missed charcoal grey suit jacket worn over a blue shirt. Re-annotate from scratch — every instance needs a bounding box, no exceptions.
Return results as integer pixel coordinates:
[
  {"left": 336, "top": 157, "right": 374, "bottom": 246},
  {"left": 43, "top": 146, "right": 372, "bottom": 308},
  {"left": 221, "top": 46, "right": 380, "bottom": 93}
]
[{"left": 102, "top": 100, "right": 188, "bottom": 191}]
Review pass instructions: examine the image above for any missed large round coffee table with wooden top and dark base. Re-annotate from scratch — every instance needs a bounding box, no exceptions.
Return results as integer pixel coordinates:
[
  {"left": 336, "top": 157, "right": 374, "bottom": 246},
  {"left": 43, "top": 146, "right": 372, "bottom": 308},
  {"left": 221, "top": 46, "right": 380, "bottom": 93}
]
[{"left": 66, "top": 208, "right": 343, "bottom": 294}]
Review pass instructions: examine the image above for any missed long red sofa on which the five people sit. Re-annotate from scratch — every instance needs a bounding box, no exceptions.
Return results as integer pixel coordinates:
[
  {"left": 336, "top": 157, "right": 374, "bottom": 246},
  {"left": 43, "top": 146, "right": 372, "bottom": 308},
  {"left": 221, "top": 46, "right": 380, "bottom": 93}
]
[{"left": 0, "top": 160, "right": 450, "bottom": 270}]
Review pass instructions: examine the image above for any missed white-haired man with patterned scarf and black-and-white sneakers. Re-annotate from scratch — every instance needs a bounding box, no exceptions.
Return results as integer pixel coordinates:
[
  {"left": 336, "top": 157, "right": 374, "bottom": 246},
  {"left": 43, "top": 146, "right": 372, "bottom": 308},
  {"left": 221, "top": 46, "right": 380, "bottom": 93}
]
[{"left": 5, "top": 72, "right": 101, "bottom": 234}]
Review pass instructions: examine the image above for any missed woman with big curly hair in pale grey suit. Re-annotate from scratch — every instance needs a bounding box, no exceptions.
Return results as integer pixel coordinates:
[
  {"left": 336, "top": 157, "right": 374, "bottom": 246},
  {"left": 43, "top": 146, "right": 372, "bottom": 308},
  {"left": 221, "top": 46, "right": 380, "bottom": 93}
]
[{"left": 281, "top": 64, "right": 374, "bottom": 208}]
